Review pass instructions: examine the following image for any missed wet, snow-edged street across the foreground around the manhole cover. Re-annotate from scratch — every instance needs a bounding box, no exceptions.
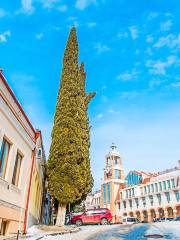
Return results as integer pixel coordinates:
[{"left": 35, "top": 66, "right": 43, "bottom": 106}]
[{"left": 40, "top": 222, "right": 180, "bottom": 240}]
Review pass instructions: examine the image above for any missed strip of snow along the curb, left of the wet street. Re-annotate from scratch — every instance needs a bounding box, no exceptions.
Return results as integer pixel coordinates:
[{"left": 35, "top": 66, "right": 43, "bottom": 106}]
[{"left": 43, "top": 225, "right": 117, "bottom": 240}]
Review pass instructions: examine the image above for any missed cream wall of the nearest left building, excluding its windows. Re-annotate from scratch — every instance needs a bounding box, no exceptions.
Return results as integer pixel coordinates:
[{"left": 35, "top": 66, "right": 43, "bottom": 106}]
[{"left": 0, "top": 75, "right": 35, "bottom": 234}]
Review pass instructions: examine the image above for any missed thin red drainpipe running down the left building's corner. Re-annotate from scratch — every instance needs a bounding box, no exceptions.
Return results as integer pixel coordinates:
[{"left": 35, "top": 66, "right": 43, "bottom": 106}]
[{"left": 23, "top": 148, "right": 36, "bottom": 234}]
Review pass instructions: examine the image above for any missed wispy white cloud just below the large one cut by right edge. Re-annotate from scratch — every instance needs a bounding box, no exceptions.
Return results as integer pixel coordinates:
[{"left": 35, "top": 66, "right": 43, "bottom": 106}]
[{"left": 146, "top": 55, "right": 177, "bottom": 75}]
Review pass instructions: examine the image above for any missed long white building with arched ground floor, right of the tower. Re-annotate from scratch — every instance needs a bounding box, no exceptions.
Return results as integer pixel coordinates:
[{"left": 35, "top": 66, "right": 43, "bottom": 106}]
[{"left": 116, "top": 161, "right": 180, "bottom": 222}]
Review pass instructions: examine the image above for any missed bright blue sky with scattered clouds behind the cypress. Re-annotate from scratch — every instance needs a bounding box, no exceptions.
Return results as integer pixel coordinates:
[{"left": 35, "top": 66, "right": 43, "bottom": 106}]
[{"left": 0, "top": 0, "right": 180, "bottom": 188}]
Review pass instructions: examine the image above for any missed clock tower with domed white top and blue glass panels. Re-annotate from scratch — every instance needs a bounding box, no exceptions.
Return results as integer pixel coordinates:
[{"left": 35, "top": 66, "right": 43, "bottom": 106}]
[{"left": 101, "top": 143, "right": 124, "bottom": 220}]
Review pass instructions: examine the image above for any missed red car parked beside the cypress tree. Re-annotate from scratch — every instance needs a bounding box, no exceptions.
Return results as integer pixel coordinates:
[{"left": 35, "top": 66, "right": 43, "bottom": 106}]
[{"left": 71, "top": 208, "right": 112, "bottom": 226}]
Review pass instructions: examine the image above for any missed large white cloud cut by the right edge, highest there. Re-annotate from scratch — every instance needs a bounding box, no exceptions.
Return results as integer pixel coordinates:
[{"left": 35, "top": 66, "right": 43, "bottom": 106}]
[{"left": 153, "top": 34, "right": 180, "bottom": 48}]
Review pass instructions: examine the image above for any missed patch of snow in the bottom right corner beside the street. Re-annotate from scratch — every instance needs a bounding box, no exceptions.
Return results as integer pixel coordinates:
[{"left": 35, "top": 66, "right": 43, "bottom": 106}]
[{"left": 146, "top": 221, "right": 180, "bottom": 240}]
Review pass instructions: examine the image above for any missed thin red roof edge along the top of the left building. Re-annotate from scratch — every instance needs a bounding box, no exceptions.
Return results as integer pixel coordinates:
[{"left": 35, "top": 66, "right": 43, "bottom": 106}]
[{"left": 0, "top": 69, "right": 36, "bottom": 134}]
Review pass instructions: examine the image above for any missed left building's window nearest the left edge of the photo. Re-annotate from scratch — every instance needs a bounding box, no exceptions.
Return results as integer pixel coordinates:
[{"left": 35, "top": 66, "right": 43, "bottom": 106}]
[{"left": 0, "top": 138, "right": 11, "bottom": 178}]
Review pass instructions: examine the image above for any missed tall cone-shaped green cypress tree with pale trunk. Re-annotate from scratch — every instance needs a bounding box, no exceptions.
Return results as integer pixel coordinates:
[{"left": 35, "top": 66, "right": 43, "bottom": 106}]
[{"left": 47, "top": 28, "right": 95, "bottom": 225}]
